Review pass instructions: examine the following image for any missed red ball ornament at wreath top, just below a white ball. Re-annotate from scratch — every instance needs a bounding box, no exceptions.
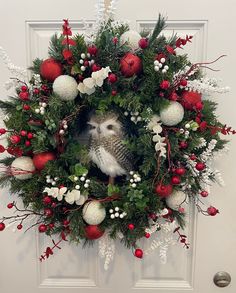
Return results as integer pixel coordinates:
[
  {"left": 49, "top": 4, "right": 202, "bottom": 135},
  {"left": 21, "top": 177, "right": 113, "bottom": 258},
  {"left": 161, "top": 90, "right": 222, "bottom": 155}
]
[{"left": 120, "top": 53, "right": 142, "bottom": 77}]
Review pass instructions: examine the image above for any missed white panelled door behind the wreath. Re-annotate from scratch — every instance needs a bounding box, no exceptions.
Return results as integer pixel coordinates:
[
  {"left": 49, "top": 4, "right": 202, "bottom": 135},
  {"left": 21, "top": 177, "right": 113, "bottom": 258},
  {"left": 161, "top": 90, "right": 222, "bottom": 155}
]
[{"left": 0, "top": 0, "right": 236, "bottom": 293}]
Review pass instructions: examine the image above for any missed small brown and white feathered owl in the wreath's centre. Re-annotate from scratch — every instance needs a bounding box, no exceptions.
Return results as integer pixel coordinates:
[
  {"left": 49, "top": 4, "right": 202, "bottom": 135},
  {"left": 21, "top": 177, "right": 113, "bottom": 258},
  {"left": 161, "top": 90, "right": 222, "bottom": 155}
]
[{"left": 88, "top": 112, "right": 132, "bottom": 179}]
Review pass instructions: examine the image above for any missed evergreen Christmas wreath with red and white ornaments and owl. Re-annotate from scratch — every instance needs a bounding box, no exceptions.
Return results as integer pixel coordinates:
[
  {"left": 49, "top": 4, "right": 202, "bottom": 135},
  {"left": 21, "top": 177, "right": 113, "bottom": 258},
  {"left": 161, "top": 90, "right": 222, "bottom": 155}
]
[{"left": 0, "top": 16, "right": 235, "bottom": 262}]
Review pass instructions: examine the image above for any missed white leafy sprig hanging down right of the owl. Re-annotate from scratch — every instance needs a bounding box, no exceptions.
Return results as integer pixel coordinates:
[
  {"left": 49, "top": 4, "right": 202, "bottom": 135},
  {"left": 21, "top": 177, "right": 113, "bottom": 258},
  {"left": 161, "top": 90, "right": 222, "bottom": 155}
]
[{"left": 147, "top": 115, "right": 166, "bottom": 158}]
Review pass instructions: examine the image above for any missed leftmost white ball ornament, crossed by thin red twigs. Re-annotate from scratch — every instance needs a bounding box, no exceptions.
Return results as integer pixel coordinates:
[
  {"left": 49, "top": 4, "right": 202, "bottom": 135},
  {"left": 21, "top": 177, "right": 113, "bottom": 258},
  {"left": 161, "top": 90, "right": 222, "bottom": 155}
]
[{"left": 11, "top": 156, "right": 35, "bottom": 180}]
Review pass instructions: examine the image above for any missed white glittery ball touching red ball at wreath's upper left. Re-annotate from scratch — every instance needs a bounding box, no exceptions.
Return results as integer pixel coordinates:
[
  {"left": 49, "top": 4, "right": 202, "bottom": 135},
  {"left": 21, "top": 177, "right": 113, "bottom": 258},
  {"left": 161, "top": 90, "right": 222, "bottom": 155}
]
[{"left": 52, "top": 75, "right": 79, "bottom": 101}]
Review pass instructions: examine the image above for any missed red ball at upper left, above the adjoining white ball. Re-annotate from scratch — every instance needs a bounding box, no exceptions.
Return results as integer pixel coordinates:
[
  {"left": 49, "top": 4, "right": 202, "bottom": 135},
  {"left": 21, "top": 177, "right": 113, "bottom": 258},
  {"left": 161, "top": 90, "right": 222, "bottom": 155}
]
[{"left": 40, "top": 58, "right": 62, "bottom": 82}]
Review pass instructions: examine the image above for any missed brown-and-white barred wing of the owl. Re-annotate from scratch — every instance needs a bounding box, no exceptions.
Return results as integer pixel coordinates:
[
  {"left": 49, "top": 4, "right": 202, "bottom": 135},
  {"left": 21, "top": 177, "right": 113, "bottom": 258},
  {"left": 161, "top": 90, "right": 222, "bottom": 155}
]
[{"left": 103, "top": 135, "right": 133, "bottom": 172}]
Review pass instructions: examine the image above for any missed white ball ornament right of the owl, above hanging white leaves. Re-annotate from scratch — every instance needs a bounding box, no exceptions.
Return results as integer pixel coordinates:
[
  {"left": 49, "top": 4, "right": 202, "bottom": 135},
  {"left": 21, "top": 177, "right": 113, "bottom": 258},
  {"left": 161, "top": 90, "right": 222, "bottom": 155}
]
[{"left": 160, "top": 101, "right": 184, "bottom": 126}]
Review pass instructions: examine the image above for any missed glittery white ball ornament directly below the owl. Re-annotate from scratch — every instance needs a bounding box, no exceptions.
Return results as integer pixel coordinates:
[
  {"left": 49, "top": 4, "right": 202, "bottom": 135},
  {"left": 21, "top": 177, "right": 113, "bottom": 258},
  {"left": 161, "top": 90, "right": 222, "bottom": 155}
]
[{"left": 82, "top": 200, "right": 106, "bottom": 225}]
